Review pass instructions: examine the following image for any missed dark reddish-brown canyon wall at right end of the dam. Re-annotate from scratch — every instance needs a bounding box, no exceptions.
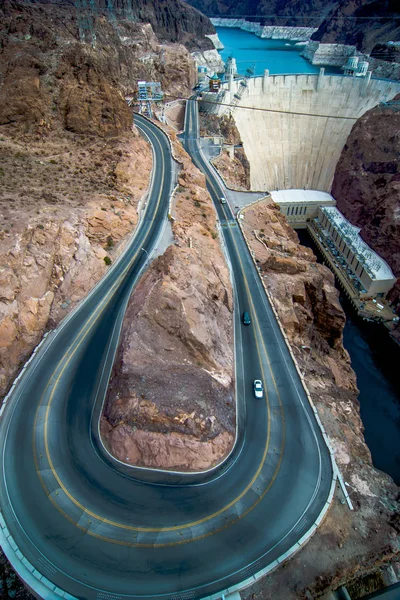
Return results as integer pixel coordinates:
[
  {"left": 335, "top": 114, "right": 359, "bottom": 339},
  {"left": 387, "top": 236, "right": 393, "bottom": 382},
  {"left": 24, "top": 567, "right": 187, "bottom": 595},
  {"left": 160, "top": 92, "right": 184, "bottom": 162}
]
[{"left": 332, "top": 95, "right": 400, "bottom": 314}]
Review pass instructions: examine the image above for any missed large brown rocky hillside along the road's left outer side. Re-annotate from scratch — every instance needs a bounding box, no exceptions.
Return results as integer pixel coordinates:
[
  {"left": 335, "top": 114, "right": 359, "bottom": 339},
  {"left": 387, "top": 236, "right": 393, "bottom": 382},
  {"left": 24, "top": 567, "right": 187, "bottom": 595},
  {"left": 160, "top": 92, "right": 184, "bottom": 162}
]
[{"left": 0, "top": 2, "right": 200, "bottom": 404}]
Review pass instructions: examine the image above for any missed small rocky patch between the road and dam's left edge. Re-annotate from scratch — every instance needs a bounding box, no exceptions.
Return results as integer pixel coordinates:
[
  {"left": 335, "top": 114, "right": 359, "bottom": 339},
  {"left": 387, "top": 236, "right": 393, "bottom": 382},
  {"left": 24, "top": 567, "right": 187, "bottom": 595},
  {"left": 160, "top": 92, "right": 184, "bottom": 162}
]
[{"left": 199, "top": 113, "right": 250, "bottom": 190}]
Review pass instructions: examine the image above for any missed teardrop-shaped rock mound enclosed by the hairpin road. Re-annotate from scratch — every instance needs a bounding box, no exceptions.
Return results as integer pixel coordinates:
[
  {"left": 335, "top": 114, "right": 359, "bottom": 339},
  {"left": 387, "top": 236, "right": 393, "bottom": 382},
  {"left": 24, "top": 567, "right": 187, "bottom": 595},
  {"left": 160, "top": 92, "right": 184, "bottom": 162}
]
[{"left": 102, "top": 129, "right": 235, "bottom": 471}]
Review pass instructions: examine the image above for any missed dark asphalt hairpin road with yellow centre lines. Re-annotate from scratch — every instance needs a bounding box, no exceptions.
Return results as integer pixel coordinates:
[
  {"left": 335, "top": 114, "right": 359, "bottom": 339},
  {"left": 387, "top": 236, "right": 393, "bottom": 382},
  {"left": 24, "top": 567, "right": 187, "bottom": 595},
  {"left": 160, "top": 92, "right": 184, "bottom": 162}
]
[{"left": 0, "top": 101, "right": 333, "bottom": 600}]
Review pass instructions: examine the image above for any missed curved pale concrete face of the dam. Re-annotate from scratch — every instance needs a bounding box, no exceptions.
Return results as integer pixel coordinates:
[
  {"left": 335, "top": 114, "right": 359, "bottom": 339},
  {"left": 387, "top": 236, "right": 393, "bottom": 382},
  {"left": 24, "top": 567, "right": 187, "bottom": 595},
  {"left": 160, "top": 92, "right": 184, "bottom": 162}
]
[{"left": 216, "top": 69, "right": 400, "bottom": 192}]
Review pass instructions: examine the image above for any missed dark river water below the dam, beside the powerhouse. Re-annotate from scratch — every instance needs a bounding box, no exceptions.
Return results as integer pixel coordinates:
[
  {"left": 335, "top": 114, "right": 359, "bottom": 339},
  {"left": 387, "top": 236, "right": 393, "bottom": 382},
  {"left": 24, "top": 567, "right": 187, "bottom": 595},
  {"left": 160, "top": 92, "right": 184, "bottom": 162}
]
[{"left": 297, "top": 230, "right": 400, "bottom": 485}]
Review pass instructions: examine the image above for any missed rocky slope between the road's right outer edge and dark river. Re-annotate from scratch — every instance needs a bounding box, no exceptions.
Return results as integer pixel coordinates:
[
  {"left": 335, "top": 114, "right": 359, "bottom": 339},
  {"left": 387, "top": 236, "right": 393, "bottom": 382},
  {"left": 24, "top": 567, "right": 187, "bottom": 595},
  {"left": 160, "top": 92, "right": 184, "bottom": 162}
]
[{"left": 242, "top": 202, "right": 400, "bottom": 600}]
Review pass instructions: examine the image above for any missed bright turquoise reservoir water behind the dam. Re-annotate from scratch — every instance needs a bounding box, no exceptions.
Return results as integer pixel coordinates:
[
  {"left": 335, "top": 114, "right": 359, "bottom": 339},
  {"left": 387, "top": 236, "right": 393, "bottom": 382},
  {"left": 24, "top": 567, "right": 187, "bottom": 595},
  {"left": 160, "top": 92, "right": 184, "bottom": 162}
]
[{"left": 215, "top": 27, "right": 342, "bottom": 75}]
